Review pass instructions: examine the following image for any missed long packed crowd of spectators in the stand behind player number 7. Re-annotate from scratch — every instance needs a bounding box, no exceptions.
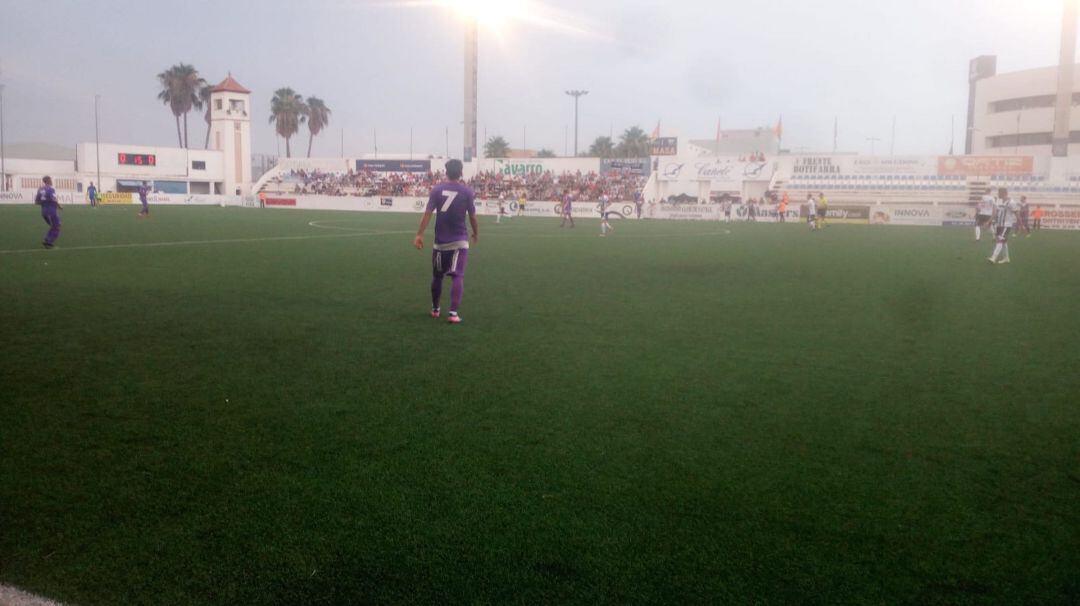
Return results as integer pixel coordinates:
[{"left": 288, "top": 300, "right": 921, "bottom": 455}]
[{"left": 267, "top": 170, "right": 646, "bottom": 202}]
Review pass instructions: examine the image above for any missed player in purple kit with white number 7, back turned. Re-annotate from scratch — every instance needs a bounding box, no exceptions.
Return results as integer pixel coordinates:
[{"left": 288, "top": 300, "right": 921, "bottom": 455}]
[{"left": 413, "top": 160, "right": 480, "bottom": 324}]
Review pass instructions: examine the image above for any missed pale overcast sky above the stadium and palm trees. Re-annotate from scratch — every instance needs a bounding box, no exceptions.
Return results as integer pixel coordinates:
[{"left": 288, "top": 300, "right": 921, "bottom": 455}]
[{"left": 0, "top": 0, "right": 1075, "bottom": 157}]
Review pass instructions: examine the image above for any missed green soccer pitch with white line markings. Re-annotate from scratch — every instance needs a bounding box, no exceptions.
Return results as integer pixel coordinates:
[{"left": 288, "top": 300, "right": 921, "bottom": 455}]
[{"left": 0, "top": 206, "right": 1080, "bottom": 605}]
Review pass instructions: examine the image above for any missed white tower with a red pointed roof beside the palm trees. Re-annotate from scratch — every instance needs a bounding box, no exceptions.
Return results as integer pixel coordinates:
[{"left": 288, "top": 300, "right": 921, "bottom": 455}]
[{"left": 210, "top": 73, "right": 252, "bottom": 196}]
